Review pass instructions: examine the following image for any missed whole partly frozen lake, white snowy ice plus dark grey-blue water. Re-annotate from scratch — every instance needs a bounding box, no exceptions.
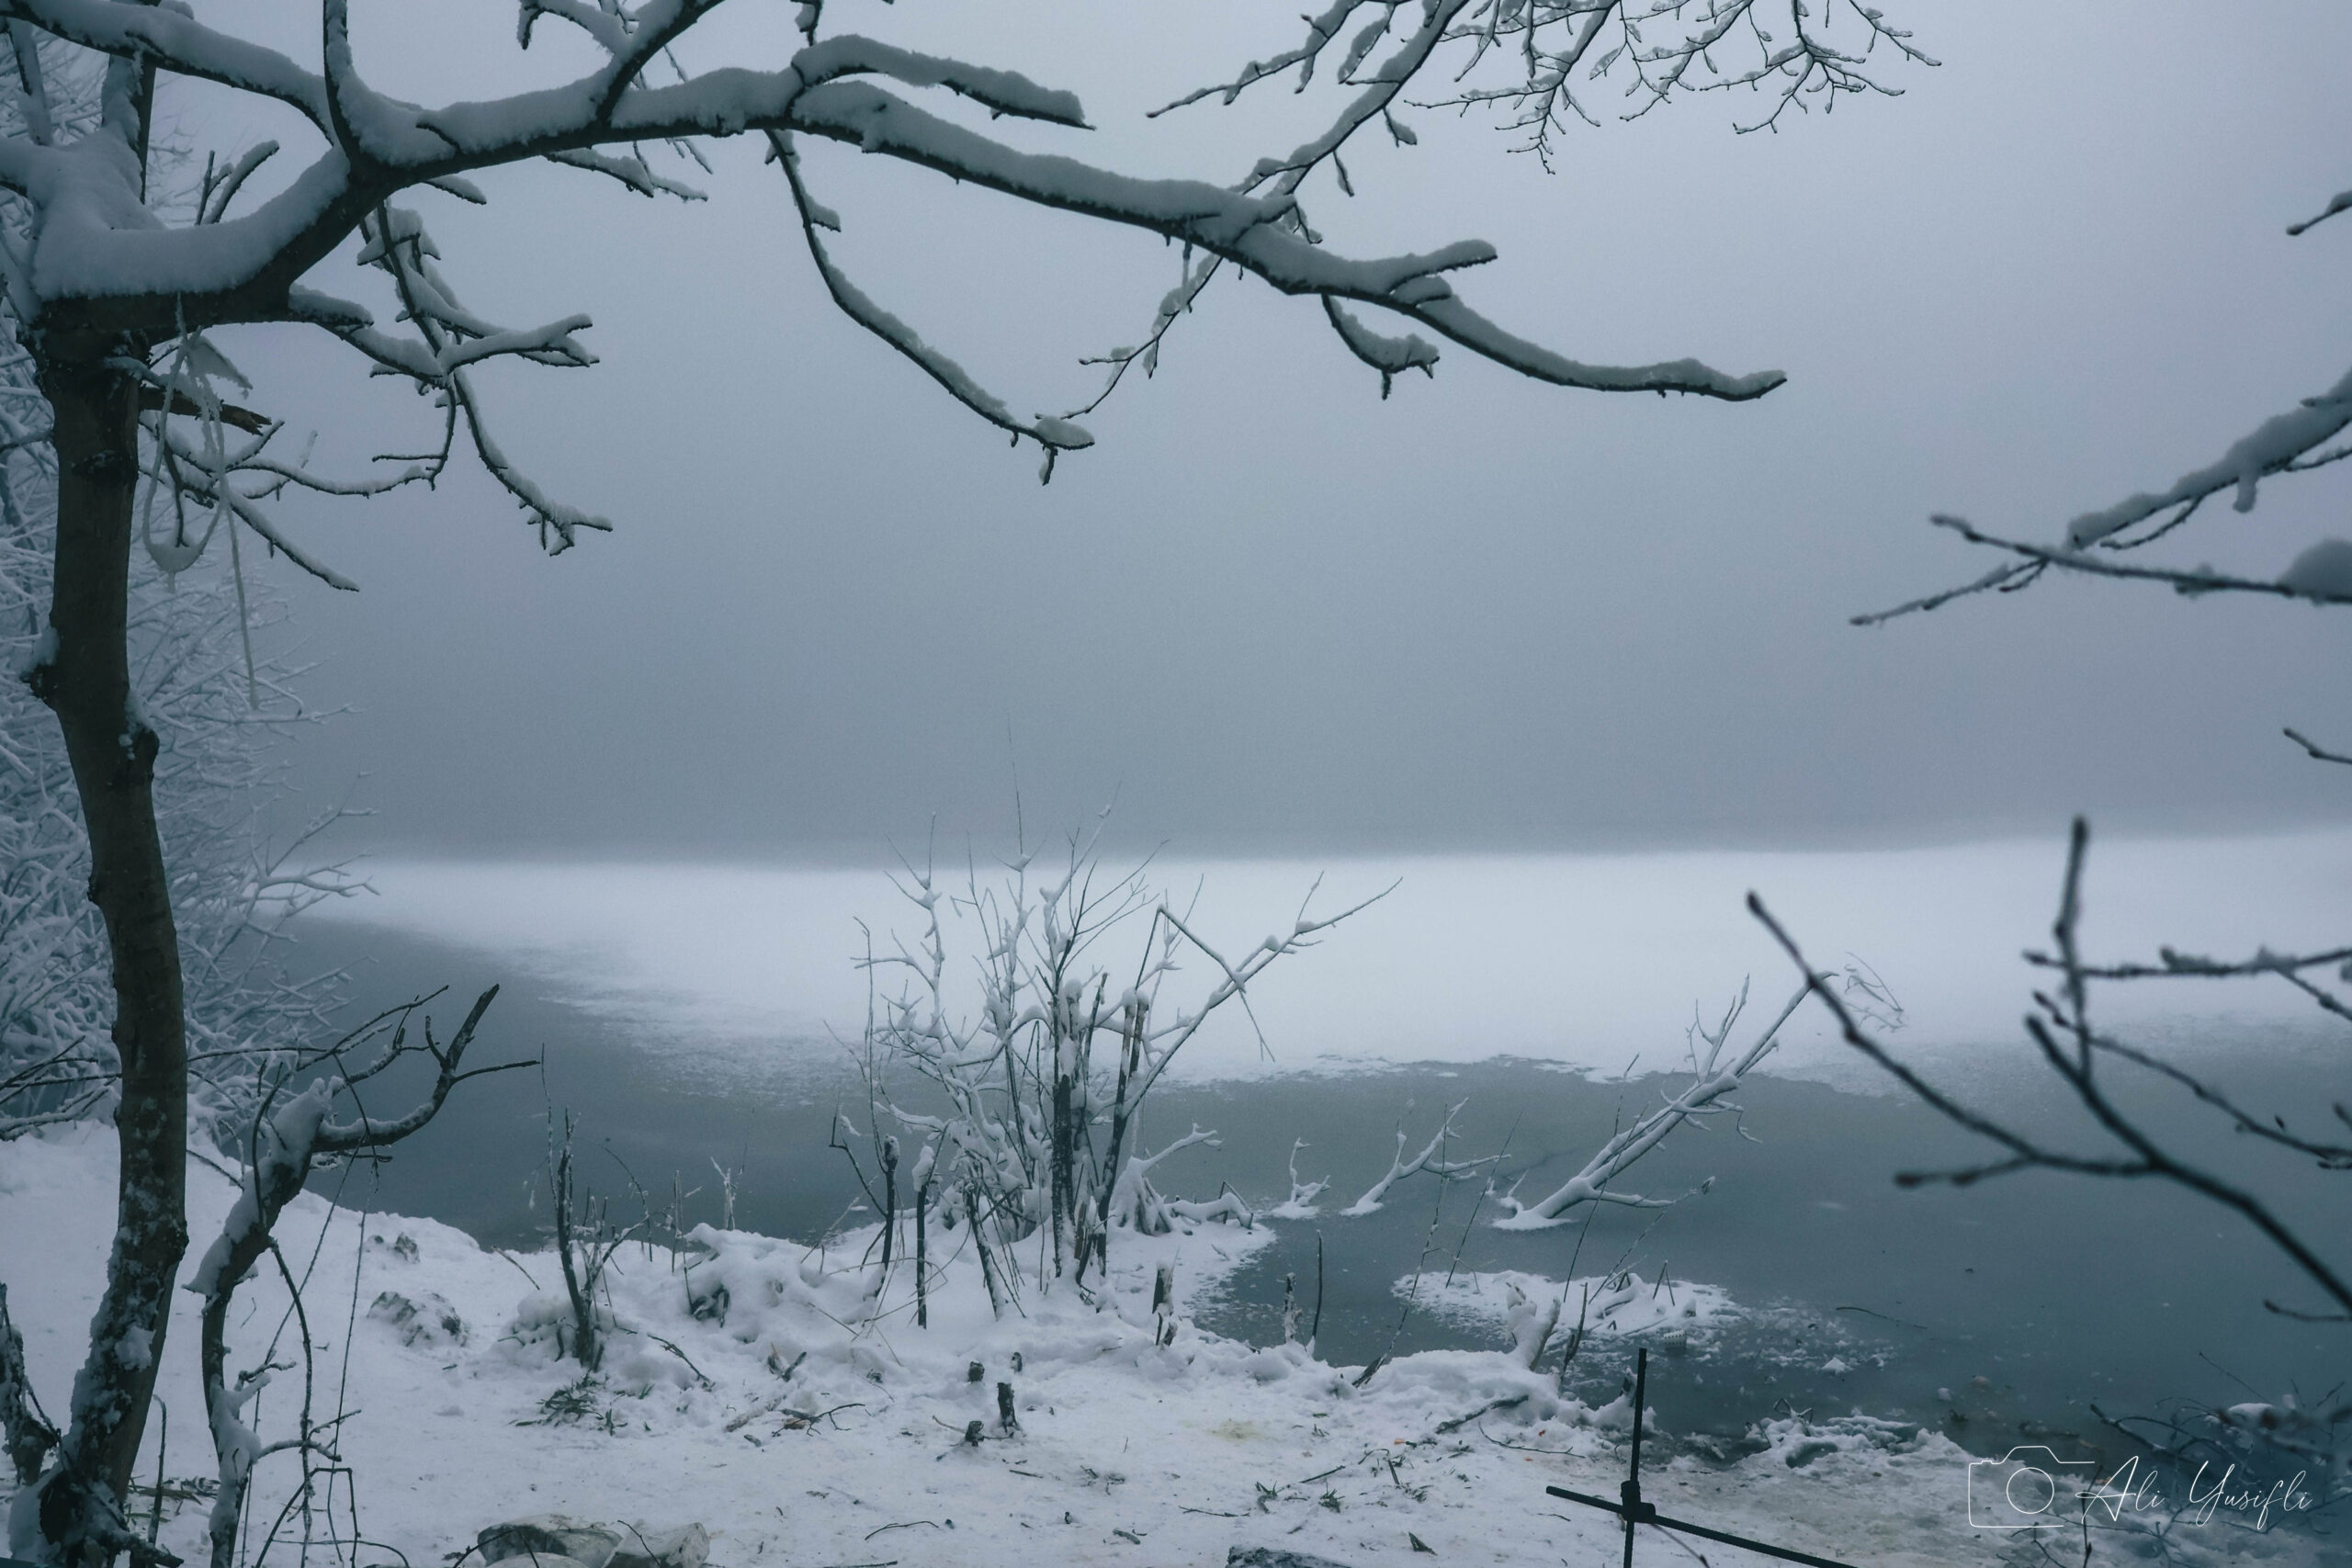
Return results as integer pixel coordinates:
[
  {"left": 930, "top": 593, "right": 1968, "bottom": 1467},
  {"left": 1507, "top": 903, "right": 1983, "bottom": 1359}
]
[{"left": 306, "top": 835, "right": 2352, "bottom": 1476}]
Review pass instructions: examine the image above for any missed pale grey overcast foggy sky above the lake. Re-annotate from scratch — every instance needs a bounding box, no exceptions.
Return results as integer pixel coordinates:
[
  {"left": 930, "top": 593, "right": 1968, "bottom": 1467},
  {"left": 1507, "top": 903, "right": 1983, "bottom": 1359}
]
[{"left": 181, "top": 0, "right": 2352, "bottom": 856}]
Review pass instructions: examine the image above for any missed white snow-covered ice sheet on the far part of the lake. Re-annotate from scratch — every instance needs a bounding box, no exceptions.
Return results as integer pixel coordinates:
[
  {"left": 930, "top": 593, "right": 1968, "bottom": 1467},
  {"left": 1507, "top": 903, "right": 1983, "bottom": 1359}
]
[{"left": 318, "top": 832, "right": 2352, "bottom": 1086}]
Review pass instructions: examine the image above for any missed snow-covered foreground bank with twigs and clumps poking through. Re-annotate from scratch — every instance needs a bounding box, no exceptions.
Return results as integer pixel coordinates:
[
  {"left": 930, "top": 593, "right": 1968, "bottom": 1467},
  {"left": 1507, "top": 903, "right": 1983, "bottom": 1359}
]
[{"left": 0, "top": 1126, "right": 2319, "bottom": 1568}]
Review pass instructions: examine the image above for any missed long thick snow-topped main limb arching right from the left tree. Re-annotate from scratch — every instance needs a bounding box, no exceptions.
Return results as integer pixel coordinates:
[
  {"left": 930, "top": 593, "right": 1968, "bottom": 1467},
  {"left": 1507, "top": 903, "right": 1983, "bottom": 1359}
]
[{"left": 0, "top": 0, "right": 1781, "bottom": 400}]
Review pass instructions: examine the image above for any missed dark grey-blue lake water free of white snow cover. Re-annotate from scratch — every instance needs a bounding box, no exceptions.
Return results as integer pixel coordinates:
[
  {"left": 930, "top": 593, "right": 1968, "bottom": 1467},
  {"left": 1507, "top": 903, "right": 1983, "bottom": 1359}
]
[{"left": 306, "top": 924, "right": 2352, "bottom": 1453}]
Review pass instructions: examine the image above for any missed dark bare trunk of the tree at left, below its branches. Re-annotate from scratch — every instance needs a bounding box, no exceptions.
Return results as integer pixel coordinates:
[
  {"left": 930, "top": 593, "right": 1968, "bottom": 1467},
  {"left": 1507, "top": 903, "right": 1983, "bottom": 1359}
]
[{"left": 26, "top": 341, "right": 188, "bottom": 1561}]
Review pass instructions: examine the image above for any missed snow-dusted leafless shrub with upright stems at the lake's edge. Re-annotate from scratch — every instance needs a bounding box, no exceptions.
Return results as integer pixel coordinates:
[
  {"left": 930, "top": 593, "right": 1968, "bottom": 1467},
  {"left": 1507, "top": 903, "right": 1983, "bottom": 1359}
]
[{"left": 842, "top": 820, "right": 1364, "bottom": 1298}]
